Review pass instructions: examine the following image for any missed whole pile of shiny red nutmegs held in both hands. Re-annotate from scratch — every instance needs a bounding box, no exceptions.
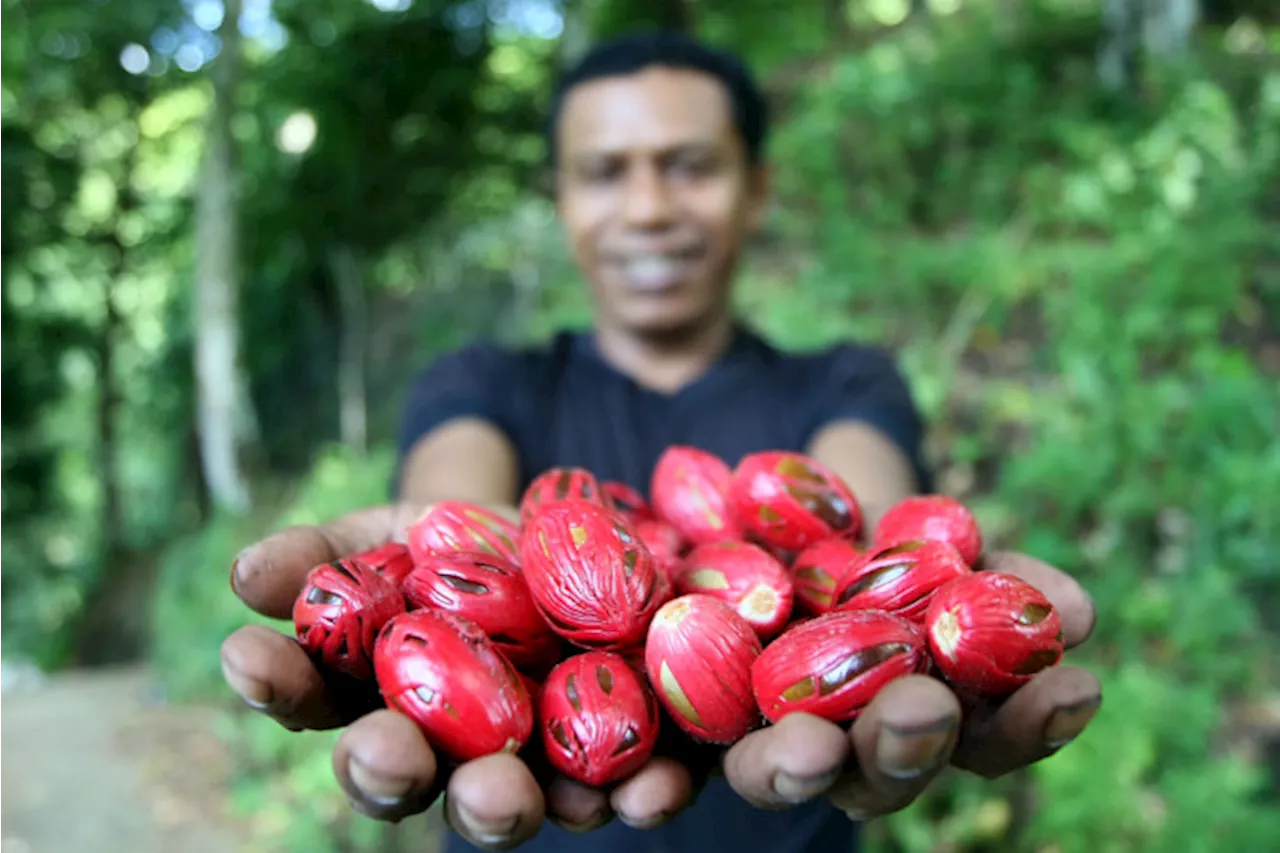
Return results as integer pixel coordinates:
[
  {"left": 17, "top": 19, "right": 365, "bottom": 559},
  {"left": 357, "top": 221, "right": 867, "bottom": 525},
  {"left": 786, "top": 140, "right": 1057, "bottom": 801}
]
[{"left": 293, "top": 446, "right": 1064, "bottom": 786}]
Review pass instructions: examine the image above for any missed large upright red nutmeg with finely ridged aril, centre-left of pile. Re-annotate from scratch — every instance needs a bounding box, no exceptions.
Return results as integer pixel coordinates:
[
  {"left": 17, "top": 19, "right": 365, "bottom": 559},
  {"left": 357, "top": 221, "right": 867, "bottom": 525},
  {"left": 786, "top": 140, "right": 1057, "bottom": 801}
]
[{"left": 521, "top": 498, "right": 663, "bottom": 651}]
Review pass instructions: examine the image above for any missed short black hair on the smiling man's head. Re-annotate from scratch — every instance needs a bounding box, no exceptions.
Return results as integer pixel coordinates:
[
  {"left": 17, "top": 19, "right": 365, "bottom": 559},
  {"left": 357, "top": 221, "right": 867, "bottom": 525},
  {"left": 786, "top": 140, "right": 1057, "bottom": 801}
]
[{"left": 544, "top": 29, "right": 769, "bottom": 168}]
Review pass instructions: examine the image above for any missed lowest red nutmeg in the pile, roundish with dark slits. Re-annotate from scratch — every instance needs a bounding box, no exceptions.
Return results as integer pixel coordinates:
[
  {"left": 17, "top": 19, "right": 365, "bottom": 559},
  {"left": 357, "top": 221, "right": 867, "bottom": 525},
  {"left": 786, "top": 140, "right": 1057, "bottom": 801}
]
[{"left": 538, "top": 652, "right": 659, "bottom": 788}]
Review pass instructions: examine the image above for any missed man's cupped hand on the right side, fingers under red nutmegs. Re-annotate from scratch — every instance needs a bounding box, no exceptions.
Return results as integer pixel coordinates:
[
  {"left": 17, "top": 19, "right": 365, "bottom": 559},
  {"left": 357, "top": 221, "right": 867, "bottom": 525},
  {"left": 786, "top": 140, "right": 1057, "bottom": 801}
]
[{"left": 724, "top": 552, "right": 1102, "bottom": 820}]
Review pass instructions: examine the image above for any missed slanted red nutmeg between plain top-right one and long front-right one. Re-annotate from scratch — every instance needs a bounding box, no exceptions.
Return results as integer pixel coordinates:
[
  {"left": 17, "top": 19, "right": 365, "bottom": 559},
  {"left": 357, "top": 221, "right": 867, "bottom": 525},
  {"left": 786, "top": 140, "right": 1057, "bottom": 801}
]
[{"left": 831, "top": 542, "right": 972, "bottom": 624}]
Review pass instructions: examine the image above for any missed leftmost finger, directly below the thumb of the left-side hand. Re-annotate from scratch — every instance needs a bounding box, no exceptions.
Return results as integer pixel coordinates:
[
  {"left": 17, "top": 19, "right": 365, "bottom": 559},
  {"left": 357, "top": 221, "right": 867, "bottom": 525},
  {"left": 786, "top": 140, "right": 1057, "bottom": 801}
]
[{"left": 221, "top": 625, "right": 380, "bottom": 731}]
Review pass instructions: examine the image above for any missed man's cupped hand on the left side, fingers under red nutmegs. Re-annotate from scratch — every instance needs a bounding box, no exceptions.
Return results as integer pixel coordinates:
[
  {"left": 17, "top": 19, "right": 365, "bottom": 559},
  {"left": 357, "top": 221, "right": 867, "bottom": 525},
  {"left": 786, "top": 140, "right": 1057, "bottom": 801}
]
[{"left": 221, "top": 505, "right": 694, "bottom": 849}]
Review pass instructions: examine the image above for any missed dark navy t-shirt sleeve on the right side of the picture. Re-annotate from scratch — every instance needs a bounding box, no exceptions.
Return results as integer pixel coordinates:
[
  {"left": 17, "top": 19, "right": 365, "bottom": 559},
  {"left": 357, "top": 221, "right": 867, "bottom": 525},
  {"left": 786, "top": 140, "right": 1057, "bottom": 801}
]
[{"left": 805, "top": 345, "right": 933, "bottom": 492}]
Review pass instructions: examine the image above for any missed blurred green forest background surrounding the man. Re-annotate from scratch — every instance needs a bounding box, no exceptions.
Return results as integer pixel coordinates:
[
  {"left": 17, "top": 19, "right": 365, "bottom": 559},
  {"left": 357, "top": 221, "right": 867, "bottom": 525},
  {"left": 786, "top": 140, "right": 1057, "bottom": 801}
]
[{"left": 0, "top": 0, "right": 1280, "bottom": 853}]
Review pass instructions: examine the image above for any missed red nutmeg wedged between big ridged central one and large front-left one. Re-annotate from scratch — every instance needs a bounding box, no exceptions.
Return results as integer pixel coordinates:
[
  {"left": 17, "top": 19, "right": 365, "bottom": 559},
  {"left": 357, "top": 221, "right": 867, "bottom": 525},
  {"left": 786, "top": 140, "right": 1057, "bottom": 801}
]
[{"left": 401, "top": 552, "right": 561, "bottom": 667}]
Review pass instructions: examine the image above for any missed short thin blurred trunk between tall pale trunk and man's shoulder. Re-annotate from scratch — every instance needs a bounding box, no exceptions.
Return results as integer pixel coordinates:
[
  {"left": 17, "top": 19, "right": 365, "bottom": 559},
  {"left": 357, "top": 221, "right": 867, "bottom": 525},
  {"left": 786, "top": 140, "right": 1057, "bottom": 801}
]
[{"left": 329, "top": 245, "right": 369, "bottom": 452}]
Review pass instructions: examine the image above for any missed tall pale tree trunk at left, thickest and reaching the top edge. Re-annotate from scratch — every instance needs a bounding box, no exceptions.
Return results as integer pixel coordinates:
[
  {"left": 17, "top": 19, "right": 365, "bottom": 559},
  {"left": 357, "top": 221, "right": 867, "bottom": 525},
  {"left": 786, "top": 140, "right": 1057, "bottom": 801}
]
[{"left": 195, "top": 0, "right": 252, "bottom": 514}]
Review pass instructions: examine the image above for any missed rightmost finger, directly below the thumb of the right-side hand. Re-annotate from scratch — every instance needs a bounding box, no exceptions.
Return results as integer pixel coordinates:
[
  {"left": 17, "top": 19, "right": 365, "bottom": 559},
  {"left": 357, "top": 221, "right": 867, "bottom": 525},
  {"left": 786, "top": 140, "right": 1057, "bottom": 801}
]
[{"left": 955, "top": 666, "right": 1102, "bottom": 779}]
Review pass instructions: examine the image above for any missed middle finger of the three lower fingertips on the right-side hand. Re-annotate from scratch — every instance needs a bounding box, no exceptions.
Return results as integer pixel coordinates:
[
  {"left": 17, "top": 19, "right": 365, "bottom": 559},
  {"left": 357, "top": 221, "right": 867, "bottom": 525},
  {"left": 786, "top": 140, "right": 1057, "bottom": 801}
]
[{"left": 831, "top": 675, "right": 961, "bottom": 820}]
